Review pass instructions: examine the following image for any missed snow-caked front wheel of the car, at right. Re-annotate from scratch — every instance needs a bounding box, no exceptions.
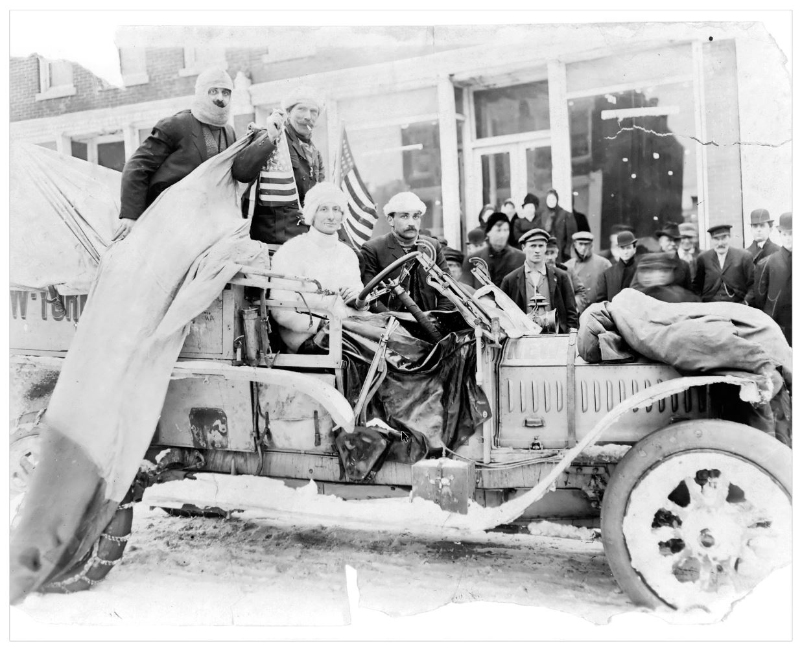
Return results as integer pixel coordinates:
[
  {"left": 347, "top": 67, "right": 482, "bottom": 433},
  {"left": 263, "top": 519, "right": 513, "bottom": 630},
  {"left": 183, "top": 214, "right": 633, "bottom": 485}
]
[{"left": 601, "top": 420, "right": 792, "bottom": 612}]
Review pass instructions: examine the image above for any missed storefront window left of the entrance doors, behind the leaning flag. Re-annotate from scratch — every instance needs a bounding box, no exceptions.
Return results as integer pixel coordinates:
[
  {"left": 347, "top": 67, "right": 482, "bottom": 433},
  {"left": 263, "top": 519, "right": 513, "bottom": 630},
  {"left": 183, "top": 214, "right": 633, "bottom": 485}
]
[{"left": 338, "top": 88, "right": 443, "bottom": 237}]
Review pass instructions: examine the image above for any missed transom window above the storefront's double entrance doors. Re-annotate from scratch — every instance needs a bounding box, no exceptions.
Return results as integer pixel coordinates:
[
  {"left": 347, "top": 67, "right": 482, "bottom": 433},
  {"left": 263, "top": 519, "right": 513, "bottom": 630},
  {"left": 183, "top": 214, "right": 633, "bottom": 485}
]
[{"left": 473, "top": 81, "right": 549, "bottom": 138}]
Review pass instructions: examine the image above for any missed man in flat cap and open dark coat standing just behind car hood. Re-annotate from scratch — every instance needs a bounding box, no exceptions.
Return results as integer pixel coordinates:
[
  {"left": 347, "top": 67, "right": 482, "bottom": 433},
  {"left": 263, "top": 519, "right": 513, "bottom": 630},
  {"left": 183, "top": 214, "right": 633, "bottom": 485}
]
[{"left": 501, "top": 228, "right": 579, "bottom": 333}]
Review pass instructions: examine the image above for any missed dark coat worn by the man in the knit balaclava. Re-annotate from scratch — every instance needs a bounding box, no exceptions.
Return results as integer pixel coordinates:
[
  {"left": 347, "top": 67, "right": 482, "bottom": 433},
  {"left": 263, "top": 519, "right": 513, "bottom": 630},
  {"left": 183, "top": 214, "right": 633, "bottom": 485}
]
[{"left": 120, "top": 110, "right": 237, "bottom": 219}]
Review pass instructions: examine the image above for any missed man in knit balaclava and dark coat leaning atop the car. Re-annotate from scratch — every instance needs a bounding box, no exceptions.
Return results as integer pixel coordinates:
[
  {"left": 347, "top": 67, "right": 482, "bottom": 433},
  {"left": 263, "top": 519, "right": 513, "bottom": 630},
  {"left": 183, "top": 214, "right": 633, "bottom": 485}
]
[{"left": 114, "top": 68, "right": 237, "bottom": 240}]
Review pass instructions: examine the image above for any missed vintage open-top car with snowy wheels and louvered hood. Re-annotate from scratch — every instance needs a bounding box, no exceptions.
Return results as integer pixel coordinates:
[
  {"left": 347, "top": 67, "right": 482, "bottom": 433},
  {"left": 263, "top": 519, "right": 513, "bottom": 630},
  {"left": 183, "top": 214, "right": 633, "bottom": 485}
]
[{"left": 11, "top": 242, "right": 791, "bottom": 609}]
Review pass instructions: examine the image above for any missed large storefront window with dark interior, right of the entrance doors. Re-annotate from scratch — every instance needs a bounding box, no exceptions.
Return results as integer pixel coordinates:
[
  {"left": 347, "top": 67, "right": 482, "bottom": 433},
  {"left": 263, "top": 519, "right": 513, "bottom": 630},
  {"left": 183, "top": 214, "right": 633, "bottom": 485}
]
[{"left": 568, "top": 48, "right": 699, "bottom": 250}]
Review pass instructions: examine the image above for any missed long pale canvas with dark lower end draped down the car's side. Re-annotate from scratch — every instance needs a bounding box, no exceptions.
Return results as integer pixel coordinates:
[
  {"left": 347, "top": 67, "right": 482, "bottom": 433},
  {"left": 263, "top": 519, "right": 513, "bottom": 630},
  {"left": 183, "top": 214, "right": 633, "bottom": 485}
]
[{"left": 11, "top": 134, "right": 272, "bottom": 599}]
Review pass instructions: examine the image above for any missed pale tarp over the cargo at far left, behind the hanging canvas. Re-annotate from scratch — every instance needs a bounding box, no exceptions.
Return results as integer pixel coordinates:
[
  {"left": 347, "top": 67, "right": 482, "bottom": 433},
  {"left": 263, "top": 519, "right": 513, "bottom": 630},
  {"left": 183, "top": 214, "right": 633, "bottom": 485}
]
[{"left": 9, "top": 143, "right": 121, "bottom": 295}]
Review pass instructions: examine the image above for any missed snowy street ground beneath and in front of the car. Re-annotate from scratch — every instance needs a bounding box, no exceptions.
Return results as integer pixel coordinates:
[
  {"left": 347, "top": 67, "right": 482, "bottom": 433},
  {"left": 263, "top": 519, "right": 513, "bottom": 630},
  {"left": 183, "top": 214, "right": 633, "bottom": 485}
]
[{"left": 12, "top": 470, "right": 790, "bottom": 639}]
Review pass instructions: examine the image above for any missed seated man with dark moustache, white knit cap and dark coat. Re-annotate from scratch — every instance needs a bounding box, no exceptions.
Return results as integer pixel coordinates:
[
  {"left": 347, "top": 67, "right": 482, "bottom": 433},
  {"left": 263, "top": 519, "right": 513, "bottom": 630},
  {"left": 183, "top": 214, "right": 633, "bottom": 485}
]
[{"left": 360, "top": 192, "right": 454, "bottom": 311}]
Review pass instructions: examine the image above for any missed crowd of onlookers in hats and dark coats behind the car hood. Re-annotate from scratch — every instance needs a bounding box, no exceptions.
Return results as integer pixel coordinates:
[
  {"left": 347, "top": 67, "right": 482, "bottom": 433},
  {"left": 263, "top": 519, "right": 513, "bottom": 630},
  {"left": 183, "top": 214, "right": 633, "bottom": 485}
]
[{"left": 432, "top": 190, "right": 792, "bottom": 345}]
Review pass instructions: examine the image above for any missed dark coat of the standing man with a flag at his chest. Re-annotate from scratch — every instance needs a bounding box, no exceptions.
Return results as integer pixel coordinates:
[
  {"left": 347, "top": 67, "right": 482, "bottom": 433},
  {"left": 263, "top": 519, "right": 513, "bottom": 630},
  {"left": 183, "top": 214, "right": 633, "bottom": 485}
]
[{"left": 231, "top": 127, "right": 326, "bottom": 244}]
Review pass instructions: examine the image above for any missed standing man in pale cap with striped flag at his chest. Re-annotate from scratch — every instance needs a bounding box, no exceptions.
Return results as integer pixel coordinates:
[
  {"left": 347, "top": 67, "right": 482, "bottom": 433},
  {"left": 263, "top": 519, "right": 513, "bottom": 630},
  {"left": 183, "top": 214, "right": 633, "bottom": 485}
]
[{"left": 231, "top": 86, "right": 325, "bottom": 244}]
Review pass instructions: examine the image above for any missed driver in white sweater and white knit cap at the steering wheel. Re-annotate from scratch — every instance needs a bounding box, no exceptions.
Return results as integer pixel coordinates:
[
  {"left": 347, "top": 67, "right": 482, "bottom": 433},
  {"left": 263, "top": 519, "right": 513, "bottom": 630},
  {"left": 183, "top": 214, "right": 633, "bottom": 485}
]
[{"left": 270, "top": 183, "right": 363, "bottom": 352}]
